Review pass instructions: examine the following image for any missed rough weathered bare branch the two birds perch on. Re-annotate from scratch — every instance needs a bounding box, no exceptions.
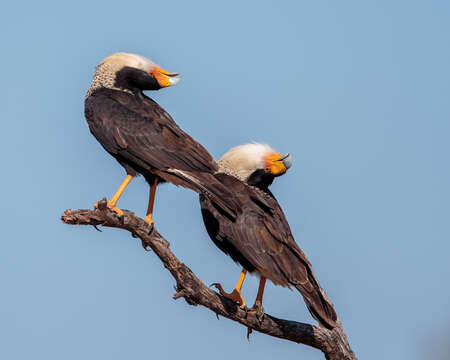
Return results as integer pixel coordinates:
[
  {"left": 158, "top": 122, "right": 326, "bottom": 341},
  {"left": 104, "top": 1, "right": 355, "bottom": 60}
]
[{"left": 61, "top": 199, "right": 356, "bottom": 360}]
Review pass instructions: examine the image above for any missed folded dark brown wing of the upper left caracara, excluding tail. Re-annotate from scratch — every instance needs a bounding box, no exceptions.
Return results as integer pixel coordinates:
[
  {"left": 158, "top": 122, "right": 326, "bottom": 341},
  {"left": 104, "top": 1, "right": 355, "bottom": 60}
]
[{"left": 86, "top": 89, "right": 217, "bottom": 172}]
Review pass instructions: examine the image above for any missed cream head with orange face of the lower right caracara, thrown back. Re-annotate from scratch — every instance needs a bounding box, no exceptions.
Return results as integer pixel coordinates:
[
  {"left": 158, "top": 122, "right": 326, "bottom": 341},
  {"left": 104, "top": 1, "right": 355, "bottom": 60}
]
[{"left": 217, "top": 143, "right": 292, "bottom": 188}]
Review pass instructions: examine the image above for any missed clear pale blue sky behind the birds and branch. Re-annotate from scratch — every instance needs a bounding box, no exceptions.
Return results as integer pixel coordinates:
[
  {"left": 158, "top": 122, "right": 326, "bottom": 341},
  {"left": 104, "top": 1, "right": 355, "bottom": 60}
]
[{"left": 0, "top": 0, "right": 450, "bottom": 360}]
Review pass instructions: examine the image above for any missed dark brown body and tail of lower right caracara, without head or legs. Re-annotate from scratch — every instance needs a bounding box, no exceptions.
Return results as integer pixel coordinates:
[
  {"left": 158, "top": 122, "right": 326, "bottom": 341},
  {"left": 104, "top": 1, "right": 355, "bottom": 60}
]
[{"left": 201, "top": 174, "right": 336, "bottom": 328}]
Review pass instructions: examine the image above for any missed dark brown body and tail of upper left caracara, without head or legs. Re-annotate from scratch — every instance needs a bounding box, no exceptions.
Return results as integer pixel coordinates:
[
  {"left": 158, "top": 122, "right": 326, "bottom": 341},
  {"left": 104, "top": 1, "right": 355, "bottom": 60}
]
[{"left": 85, "top": 89, "right": 237, "bottom": 218}]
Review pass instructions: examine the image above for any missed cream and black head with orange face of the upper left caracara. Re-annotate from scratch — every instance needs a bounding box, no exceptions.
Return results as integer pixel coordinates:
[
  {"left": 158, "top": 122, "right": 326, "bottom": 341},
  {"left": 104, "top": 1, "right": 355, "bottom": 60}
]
[{"left": 89, "top": 53, "right": 181, "bottom": 91}]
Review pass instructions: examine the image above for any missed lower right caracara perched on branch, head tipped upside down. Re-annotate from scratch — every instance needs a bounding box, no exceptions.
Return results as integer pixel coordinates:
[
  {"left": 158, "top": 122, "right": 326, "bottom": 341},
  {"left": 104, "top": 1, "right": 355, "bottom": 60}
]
[{"left": 200, "top": 143, "right": 337, "bottom": 332}]
